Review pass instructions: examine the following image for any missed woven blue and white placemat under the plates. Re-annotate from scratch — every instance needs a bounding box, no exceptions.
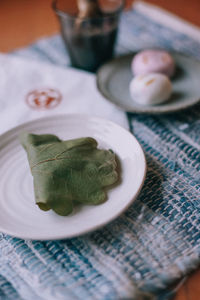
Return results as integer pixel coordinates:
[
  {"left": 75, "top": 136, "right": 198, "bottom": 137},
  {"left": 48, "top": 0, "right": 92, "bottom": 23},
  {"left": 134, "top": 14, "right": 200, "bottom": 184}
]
[{"left": 0, "top": 4, "right": 200, "bottom": 300}]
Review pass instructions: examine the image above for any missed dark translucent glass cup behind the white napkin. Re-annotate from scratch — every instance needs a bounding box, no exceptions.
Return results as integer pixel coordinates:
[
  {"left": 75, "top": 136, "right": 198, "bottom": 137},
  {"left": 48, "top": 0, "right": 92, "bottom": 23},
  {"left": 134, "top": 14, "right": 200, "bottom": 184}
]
[{"left": 53, "top": 0, "right": 124, "bottom": 72}]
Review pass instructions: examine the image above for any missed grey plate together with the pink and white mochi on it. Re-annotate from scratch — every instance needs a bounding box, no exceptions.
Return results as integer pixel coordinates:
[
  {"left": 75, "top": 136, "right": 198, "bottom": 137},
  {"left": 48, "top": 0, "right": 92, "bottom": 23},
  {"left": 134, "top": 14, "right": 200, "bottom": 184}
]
[{"left": 97, "top": 49, "right": 200, "bottom": 114}]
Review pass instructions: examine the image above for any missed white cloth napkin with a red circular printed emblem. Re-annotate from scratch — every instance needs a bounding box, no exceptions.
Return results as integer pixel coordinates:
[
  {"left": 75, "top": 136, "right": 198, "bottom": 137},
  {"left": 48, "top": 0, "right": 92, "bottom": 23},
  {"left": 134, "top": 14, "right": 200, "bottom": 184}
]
[{"left": 0, "top": 54, "right": 128, "bottom": 134}]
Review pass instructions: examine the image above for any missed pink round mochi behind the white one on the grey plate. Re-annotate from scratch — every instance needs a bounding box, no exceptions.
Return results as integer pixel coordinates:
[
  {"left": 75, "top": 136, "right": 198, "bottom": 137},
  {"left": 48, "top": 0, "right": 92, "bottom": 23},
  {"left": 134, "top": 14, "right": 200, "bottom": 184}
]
[{"left": 131, "top": 50, "right": 175, "bottom": 77}]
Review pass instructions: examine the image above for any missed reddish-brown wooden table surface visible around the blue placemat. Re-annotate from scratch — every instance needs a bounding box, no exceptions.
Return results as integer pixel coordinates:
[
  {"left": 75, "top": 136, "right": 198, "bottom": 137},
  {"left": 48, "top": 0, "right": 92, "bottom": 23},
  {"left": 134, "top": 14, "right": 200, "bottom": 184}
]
[{"left": 0, "top": 0, "right": 200, "bottom": 300}]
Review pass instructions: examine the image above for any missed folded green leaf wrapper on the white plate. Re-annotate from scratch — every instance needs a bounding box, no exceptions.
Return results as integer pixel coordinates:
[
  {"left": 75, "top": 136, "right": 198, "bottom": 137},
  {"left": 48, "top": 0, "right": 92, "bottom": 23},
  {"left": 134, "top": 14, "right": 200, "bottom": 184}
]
[{"left": 20, "top": 133, "right": 118, "bottom": 216}]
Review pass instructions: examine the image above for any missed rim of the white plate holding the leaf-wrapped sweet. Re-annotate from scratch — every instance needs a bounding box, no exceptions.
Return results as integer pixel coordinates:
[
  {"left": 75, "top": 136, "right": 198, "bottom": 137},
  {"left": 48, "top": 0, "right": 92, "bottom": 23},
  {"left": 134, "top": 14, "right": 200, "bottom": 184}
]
[{"left": 0, "top": 113, "right": 147, "bottom": 241}]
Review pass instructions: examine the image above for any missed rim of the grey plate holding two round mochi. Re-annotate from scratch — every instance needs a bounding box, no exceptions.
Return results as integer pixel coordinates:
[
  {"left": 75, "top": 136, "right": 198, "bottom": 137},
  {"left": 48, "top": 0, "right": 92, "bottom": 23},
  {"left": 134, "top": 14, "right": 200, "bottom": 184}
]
[{"left": 96, "top": 51, "right": 200, "bottom": 115}]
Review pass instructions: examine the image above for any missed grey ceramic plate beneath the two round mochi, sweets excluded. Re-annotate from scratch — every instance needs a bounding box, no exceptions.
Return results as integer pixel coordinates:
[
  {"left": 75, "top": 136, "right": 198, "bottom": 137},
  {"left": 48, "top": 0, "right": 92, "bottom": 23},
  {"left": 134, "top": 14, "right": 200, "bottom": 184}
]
[{"left": 97, "top": 52, "right": 200, "bottom": 114}]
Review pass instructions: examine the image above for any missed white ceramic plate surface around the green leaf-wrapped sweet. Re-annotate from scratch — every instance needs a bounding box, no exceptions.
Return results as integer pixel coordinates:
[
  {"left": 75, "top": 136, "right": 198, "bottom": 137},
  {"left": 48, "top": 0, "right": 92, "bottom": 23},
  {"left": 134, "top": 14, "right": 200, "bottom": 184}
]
[{"left": 0, "top": 115, "right": 146, "bottom": 240}]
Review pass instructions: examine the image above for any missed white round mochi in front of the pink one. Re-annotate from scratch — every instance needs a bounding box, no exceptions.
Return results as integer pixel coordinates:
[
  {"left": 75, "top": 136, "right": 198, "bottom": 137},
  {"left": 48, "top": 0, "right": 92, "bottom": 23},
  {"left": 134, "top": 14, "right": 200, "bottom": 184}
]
[{"left": 130, "top": 73, "right": 172, "bottom": 105}]
